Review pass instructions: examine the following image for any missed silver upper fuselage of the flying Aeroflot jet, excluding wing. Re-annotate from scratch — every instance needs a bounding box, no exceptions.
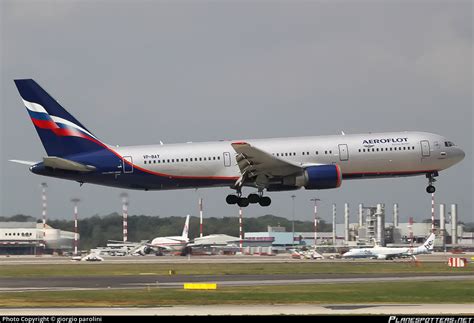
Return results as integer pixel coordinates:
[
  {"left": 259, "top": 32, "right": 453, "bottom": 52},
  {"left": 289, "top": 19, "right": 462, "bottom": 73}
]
[{"left": 114, "top": 131, "right": 464, "bottom": 189}]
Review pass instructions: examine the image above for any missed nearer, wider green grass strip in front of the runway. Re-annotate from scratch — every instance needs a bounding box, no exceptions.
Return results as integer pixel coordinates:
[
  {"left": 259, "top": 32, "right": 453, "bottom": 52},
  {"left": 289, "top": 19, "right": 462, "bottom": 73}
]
[{"left": 0, "top": 280, "right": 474, "bottom": 307}]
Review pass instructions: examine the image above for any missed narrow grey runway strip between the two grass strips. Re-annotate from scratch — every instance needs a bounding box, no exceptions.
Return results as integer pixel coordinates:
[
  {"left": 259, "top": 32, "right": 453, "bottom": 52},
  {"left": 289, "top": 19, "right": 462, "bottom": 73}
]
[{"left": 0, "top": 273, "right": 474, "bottom": 292}]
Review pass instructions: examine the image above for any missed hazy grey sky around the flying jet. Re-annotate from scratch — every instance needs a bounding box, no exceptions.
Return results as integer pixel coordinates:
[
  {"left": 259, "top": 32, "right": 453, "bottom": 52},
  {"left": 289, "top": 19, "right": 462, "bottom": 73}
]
[{"left": 0, "top": 0, "right": 474, "bottom": 227}]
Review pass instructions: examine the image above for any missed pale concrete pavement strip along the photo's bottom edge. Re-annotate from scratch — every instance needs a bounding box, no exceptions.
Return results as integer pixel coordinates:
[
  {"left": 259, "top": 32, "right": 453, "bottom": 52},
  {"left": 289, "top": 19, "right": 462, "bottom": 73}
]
[{"left": 0, "top": 304, "right": 474, "bottom": 316}]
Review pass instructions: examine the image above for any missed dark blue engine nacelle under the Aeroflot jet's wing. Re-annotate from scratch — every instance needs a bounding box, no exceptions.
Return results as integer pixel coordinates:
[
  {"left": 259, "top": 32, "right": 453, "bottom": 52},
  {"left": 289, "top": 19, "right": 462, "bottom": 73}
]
[{"left": 302, "top": 165, "right": 342, "bottom": 190}]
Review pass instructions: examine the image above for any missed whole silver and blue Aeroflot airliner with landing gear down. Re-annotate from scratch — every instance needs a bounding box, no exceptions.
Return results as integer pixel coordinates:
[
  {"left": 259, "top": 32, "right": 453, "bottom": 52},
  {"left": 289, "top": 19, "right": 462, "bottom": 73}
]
[{"left": 9, "top": 79, "right": 464, "bottom": 207}]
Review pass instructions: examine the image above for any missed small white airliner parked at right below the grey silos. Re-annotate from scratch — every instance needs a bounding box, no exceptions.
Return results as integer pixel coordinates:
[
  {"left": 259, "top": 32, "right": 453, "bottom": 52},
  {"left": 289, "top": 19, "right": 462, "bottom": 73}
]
[{"left": 342, "top": 233, "right": 435, "bottom": 259}]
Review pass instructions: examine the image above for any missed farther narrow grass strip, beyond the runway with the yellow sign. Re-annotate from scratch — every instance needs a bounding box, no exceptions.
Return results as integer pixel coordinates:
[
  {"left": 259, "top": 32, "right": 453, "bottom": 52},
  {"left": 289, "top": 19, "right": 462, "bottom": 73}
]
[{"left": 0, "top": 262, "right": 474, "bottom": 277}]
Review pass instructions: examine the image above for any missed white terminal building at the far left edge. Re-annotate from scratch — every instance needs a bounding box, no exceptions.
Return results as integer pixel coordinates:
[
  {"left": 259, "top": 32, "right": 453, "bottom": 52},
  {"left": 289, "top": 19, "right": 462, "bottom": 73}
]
[{"left": 0, "top": 222, "right": 74, "bottom": 255}]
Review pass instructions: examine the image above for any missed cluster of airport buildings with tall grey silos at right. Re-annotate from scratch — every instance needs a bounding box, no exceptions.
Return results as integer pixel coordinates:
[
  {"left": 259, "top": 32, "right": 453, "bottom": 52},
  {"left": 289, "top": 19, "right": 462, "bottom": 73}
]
[{"left": 245, "top": 203, "right": 474, "bottom": 250}]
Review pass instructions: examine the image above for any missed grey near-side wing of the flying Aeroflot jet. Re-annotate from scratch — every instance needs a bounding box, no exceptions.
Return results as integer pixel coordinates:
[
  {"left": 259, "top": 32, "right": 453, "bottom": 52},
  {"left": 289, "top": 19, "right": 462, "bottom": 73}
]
[{"left": 232, "top": 142, "right": 303, "bottom": 178}]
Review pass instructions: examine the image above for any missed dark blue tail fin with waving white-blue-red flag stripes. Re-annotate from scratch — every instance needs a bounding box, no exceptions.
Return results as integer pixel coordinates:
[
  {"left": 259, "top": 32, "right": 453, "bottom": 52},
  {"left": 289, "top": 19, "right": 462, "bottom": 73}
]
[{"left": 15, "top": 79, "right": 106, "bottom": 157}]
